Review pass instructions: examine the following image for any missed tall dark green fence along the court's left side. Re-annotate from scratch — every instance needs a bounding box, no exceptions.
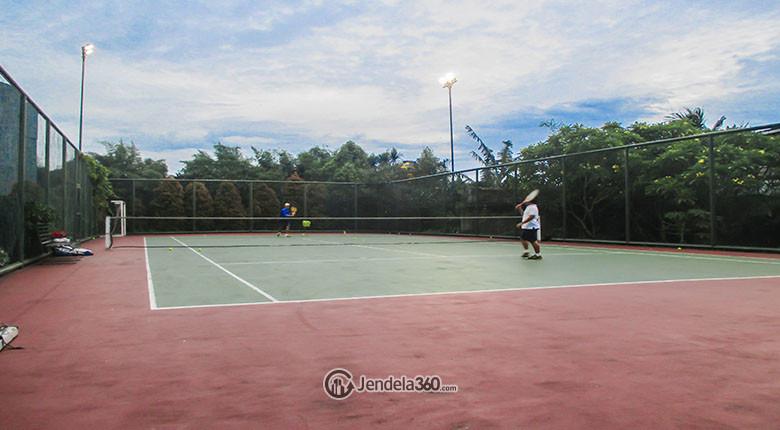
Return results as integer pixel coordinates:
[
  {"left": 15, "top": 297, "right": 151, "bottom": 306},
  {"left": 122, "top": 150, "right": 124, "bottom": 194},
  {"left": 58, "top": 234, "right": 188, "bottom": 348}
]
[{"left": 0, "top": 68, "right": 99, "bottom": 266}]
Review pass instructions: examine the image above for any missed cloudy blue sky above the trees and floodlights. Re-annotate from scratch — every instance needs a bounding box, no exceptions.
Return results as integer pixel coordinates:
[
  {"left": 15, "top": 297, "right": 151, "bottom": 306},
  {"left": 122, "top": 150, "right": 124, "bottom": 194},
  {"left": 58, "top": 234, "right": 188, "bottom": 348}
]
[{"left": 0, "top": 0, "right": 780, "bottom": 172}]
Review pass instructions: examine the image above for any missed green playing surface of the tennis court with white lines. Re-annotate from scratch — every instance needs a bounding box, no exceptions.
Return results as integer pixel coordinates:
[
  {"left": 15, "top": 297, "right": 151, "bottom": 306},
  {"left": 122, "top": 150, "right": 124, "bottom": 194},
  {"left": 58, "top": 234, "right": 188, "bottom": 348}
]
[{"left": 145, "top": 234, "right": 780, "bottom": 309}]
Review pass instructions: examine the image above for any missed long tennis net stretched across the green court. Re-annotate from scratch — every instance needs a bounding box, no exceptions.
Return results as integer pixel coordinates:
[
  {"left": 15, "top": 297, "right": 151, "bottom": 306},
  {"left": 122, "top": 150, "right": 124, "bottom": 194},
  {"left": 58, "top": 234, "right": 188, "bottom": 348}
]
[{"left": 106, "top": 216, "right": 519, "bottom": 248}]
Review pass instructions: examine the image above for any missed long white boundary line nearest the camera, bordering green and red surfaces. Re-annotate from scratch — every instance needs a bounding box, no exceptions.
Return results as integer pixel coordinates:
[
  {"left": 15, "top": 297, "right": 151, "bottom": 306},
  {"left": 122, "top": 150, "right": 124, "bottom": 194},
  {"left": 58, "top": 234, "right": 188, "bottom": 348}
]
[{"left": 151, "top": 275, "right": 780, "bottom": 310}]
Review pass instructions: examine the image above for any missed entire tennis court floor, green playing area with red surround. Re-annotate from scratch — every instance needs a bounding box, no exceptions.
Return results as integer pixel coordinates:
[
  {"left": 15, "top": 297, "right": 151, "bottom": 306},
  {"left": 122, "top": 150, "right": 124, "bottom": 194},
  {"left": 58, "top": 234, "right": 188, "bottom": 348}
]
[{"left": 0, "top": 233, "right": 780, "bottom": 429}]
